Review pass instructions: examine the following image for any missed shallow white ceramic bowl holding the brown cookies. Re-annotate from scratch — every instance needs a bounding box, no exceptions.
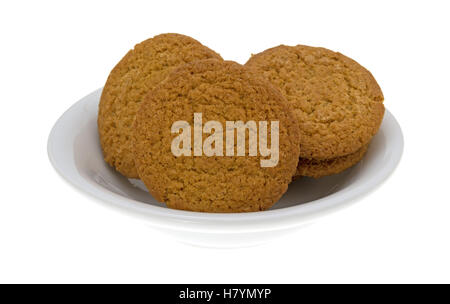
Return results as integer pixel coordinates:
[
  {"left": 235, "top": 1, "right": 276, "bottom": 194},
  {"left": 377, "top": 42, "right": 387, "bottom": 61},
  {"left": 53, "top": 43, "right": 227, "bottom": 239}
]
[{"left": 48, "top": 89, "right": 403, "bottom": 247}]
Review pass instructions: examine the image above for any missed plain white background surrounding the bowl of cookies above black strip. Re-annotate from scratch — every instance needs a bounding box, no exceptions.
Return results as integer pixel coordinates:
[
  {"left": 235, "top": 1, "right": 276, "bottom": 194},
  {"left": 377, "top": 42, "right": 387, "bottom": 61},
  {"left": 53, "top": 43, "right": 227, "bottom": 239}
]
[{"left": 0, "top": 0, "right": 450, "bottom": 283}]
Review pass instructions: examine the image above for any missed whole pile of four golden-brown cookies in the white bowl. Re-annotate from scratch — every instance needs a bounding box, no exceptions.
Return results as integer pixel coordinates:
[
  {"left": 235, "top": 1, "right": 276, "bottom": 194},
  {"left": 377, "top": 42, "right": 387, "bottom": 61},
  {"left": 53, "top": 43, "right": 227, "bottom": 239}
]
[{"left": 98, "top": 34, "right": 384, "bottom": 212}]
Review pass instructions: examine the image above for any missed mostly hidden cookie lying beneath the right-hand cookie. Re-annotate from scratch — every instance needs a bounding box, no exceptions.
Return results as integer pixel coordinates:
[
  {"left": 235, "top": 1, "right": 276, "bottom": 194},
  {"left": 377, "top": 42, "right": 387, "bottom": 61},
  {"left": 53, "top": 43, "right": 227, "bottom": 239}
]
[{"left": 294, "top": 145, "right": 368, "bottom": 179}]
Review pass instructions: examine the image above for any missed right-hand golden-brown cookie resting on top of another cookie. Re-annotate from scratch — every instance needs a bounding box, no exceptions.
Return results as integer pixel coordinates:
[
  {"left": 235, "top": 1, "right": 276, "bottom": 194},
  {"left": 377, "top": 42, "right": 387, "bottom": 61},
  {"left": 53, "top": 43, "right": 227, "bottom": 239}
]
[{"left": 246, "top": 45, "right": 384, "bottom": 159}]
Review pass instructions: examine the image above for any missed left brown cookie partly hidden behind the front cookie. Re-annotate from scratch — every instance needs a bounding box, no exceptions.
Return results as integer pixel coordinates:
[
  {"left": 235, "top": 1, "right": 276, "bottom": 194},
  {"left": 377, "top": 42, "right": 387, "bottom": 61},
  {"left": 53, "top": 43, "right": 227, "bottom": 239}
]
[{"left": 98, "top": 34, "right": 221, "bottom": 178}]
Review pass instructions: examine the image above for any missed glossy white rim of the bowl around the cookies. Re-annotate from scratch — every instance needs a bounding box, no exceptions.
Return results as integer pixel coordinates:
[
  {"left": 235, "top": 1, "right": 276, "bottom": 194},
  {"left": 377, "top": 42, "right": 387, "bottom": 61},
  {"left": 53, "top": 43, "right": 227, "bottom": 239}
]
[{"left": 47, "top": 88, "right": 404, "bottom": 233}]
